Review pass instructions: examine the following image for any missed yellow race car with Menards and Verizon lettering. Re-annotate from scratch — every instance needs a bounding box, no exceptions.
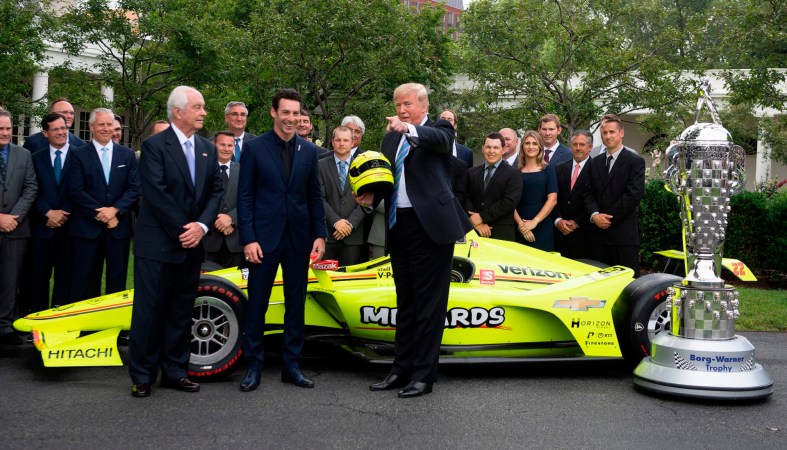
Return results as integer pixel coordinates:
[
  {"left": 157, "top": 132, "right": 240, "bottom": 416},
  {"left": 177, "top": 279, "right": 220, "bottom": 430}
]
[{"left": 14, "top": 236, "right": 740, "bottom": 378}]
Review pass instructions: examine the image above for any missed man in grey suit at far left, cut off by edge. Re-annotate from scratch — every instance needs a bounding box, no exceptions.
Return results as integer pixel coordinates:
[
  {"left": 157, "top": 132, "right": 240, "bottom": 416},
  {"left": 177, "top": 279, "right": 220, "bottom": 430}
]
[{"left": 0, "top": 108, "right": 38, "bottom": 345}]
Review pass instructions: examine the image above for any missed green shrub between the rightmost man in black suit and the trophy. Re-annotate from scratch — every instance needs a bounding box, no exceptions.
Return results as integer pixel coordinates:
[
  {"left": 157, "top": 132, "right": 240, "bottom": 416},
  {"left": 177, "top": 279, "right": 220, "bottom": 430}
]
[{"left": 638, "top": 178, "right": 683, "bottom": 267}]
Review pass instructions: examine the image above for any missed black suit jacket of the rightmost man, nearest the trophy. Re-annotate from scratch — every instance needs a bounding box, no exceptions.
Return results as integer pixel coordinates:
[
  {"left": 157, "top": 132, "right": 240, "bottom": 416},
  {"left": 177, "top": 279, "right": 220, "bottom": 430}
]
[{"left": 575, "top": 147, "right": 645, "bottom": 245}]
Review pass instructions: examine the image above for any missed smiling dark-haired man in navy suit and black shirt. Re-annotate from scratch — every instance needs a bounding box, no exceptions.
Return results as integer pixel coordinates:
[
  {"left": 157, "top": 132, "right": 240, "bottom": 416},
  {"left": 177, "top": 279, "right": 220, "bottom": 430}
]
[{"left": 238, "top": 89, "right": 327, "bottom": 392}]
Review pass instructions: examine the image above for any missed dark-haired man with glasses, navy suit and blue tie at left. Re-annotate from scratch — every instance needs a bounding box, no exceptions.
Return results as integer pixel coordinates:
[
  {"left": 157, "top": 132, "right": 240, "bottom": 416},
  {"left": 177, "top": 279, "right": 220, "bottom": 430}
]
[{"left": 24, "top": 113, "right": 80, "bottom": 312}]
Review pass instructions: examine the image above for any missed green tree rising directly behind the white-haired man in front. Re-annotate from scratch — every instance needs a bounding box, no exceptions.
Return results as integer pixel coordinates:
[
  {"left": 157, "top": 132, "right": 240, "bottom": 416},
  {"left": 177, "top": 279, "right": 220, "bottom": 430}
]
[{"left": 58, "top": 0, "right": 233, "bottom": 148}]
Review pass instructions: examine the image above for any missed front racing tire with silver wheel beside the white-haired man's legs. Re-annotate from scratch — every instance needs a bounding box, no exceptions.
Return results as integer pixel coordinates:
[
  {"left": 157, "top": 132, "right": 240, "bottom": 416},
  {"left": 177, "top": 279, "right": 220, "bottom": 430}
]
[{"left": 189, "top": 275, "right": 246, "bottom": 380}]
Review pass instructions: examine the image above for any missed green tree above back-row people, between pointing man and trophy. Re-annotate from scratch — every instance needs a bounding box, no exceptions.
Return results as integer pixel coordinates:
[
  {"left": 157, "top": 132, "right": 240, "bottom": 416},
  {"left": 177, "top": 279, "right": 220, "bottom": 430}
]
[{"left": 461, "top": 0, "right": 689, "bottom": 136}]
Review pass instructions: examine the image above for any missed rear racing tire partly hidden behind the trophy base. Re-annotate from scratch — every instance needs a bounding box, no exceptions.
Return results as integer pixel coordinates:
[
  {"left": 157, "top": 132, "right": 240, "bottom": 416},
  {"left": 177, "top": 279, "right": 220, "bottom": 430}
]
[{"left": 617, "top": 273, "right": 681, "bottom": 366}]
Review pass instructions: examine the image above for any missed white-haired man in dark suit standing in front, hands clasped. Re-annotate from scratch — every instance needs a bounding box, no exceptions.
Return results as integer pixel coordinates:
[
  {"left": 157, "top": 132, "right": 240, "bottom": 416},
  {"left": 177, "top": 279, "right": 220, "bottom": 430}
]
[{"left": 128, "top": 86, "right": 224, "bottom": 397}]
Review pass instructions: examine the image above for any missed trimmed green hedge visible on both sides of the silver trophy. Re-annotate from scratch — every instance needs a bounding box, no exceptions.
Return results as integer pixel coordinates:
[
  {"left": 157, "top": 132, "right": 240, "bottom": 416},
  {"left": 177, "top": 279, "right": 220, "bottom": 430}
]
[{"left": 638, "top": 179, "right": 787, "bottom": 273}]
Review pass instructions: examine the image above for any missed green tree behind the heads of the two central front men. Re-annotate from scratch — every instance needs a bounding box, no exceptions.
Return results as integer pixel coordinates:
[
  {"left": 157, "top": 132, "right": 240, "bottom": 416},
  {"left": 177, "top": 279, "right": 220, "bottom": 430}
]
[{"left": 246, "top": 0, "right": 452, "bottom": 147}]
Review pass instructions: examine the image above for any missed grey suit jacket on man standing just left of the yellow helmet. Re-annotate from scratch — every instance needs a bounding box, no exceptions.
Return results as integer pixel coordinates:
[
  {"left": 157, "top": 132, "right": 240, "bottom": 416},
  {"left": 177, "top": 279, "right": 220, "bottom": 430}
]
[{"left": 317, "top": 156, "right": 365, "bottom": 245}]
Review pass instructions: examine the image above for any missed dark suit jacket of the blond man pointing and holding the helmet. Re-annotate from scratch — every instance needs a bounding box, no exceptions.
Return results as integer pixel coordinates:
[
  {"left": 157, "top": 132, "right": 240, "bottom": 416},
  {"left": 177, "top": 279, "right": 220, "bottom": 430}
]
[{"left": 381, "top": 118, "right": 473, "bottom": 245}]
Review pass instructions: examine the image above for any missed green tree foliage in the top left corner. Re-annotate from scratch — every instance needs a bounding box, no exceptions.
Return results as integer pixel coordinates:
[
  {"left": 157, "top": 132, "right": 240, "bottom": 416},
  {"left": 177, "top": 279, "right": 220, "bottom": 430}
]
[{"left": 0, "top": 0, "right": 51, "bottom": 115}]
